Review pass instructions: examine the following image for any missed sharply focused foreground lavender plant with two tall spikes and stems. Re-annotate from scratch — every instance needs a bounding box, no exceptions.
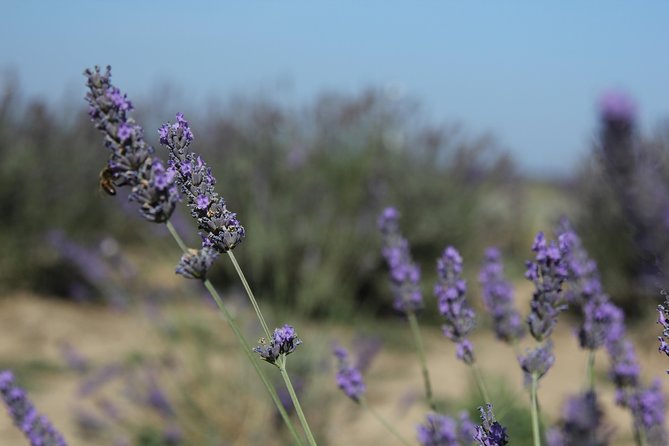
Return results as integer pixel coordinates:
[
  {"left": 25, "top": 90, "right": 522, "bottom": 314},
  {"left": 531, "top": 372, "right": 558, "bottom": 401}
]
[{"left": 84, "top": 67, "right": 316, "bottom": 446}]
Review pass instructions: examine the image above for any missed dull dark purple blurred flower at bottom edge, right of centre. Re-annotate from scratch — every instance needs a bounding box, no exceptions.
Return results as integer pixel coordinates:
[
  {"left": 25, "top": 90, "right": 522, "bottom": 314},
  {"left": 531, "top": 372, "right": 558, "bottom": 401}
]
[{"left": 548, "top": 392, "right": 612, "bottom": 446}]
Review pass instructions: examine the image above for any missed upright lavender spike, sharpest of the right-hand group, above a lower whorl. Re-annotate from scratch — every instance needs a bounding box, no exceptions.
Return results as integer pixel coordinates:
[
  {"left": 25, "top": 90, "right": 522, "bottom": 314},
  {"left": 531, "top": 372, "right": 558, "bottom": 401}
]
[{"left": 525, "top": 232, "right": 568, "bottom": 341}]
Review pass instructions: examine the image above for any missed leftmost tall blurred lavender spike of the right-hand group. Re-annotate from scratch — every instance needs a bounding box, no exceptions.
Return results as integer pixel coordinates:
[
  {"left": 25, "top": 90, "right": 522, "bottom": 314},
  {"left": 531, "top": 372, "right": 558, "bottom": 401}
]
[{"left": 378, "top": 208, "right": 423, "bottom": 313}]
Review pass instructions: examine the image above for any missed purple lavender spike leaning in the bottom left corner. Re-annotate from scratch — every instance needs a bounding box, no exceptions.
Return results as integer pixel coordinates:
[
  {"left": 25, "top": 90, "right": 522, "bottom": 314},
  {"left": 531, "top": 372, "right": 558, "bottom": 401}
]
[{"left": 0, "top": 370, "right": 67, "bottom": 446}]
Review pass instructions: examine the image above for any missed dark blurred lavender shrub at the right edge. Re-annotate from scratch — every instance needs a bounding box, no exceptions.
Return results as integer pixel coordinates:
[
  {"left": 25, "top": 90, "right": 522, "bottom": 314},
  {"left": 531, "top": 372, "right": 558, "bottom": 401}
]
[{"left": 569, "top": 101, "right": 669, "bottom": 315}]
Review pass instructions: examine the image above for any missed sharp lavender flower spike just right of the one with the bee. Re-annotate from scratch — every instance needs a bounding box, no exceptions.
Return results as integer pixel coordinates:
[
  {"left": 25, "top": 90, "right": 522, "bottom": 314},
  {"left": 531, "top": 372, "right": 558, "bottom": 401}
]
[{"left": 158, "top": 113, "right": 246, "bottom": 253}]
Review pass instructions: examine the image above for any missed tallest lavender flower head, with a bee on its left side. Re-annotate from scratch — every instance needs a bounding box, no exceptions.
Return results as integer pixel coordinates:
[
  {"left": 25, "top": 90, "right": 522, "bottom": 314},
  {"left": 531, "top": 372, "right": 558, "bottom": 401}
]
[{"left": 84, "top": 66, "right": 179, "bottom": 223}]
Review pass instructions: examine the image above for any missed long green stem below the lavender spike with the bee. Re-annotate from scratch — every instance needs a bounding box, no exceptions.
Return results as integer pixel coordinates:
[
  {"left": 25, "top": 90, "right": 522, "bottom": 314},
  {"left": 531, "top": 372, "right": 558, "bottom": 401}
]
[{"left": 165, "top": 220, "right": 303, "bottom": 446}]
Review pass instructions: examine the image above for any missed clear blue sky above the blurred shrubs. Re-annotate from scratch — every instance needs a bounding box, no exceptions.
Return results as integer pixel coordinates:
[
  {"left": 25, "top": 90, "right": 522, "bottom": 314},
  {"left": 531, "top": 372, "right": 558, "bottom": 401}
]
[{"left": 0, "top": 0, "right": 669, "bottom": 173}]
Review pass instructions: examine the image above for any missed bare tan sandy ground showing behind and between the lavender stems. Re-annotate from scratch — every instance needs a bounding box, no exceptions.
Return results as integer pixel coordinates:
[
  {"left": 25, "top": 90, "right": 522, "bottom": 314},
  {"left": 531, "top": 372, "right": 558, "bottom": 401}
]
[{"left": 0, "top": 295, "right": 669, "bottom": 446}]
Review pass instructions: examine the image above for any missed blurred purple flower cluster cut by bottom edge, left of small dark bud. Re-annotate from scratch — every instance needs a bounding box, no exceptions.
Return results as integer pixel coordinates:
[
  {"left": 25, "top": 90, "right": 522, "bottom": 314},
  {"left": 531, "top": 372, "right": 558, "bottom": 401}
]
[{"left": 417, "top": 412, "right": 476, "bottom": 446}]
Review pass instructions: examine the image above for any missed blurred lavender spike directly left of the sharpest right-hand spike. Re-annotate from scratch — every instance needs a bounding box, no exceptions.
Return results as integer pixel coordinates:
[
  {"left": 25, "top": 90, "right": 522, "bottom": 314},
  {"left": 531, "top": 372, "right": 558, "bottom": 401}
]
[{"left": 479, "top": 248, "right": 525, "bottom": 342}]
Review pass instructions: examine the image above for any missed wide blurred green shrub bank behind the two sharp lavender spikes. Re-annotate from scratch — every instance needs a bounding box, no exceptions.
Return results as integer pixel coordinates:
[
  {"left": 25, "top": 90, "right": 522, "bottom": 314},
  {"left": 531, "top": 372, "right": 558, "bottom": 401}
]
[{"left": 0, "top": 78, "right": 529, "bottom": 316}]
